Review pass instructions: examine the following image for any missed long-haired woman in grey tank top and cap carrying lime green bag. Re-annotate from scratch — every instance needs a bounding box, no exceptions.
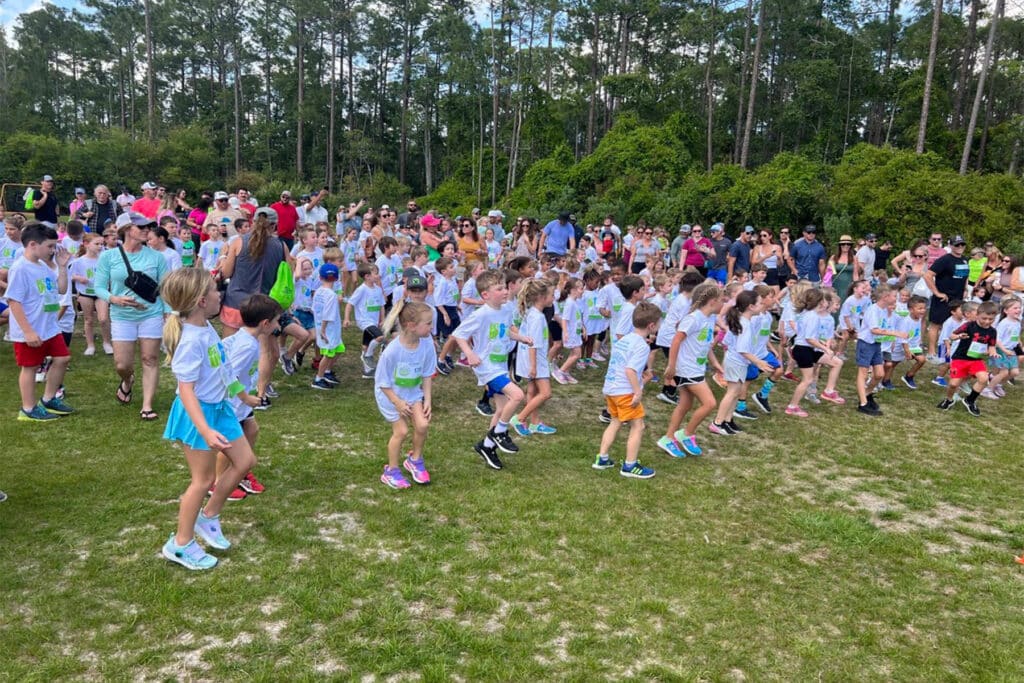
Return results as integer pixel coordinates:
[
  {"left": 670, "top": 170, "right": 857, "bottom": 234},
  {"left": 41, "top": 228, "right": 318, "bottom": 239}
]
[{"left": 220, "top": 207, "right": 295, "bottom": 400}]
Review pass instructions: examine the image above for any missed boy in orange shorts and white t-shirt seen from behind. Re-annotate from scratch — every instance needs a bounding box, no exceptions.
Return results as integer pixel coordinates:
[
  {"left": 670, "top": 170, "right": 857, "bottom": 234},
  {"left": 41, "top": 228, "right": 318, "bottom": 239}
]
[{"left": 592, "top": 302, "right": 662, "bottom": 479}]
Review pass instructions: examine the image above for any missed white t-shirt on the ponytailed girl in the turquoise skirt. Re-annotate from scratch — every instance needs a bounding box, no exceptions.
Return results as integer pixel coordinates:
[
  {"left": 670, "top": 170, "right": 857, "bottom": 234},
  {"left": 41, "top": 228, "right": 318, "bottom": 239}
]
[{"left": 171, "top": 321, "right": 240, "bottom": 403}]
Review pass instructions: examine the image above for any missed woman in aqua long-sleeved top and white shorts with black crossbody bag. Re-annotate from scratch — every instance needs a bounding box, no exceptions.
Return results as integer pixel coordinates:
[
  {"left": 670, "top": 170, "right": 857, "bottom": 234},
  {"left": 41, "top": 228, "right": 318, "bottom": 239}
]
[{"left": 95, "top": 213, "right": 169, "bottom": 421}]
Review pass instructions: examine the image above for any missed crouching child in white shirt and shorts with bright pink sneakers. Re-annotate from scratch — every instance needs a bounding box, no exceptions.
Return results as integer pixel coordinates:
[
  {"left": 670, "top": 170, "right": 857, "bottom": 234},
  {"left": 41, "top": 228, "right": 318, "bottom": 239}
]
[{"left": 374, "top": 300, "right": 437, "bottom": 489}]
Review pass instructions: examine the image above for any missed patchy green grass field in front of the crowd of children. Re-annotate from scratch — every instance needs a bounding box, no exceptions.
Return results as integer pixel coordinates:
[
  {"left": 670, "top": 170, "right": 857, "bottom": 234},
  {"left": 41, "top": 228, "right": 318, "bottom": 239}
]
[{"left": 0, "top": 327, "right": 1024, "bottom": 681}]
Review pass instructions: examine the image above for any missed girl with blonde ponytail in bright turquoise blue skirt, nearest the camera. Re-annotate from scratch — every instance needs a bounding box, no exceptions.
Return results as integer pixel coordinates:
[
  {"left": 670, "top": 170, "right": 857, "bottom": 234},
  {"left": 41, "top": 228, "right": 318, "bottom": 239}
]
[{"left": 160, "top": 268, "right": 256, "bottom": 569}]
